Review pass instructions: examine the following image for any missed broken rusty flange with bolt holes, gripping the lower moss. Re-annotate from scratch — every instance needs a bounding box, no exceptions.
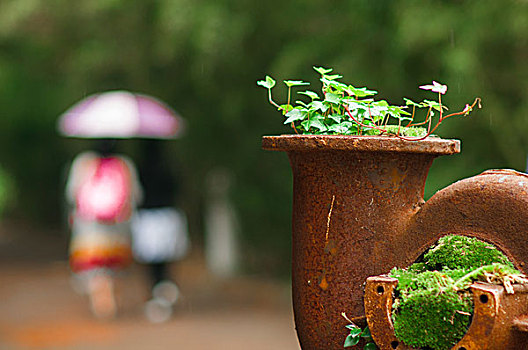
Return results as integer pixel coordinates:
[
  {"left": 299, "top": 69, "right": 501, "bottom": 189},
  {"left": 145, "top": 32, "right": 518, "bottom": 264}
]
[{"left": 365, "top": 276, "right": 528, "bottom": 350}]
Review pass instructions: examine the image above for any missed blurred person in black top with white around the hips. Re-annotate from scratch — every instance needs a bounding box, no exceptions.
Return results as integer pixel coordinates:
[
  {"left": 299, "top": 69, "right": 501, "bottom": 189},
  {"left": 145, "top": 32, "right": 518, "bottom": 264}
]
[{"left": 132, "top": 139, "right": 189, "bottom": 323}]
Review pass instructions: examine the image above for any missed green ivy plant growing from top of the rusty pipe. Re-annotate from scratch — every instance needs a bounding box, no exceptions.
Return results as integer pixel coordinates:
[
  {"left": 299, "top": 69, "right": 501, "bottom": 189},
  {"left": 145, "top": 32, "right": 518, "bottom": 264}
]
[{"left": 257, "top": 67, "right": 480, "bottom": 140}]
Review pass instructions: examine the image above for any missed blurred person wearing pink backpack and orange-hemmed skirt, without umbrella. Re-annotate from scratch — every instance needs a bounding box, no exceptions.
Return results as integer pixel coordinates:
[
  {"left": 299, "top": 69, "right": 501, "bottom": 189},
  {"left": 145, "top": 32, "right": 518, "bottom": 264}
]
[{"left": 66, "top": 140, "right": 141, "bottom": 318}]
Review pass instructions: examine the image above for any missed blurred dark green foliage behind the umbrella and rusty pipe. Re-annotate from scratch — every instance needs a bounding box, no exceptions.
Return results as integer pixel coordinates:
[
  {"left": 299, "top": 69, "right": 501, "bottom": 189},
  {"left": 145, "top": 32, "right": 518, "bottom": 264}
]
[{"left": 0, "top": 0, "right": 528, "bottom": 273}]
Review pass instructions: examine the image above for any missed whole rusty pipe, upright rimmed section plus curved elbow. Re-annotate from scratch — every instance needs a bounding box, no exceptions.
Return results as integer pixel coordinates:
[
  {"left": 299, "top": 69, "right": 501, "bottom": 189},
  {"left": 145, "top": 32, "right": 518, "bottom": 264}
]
[{"left": 262, "top": 135, "right": 528, "bottom": 350}]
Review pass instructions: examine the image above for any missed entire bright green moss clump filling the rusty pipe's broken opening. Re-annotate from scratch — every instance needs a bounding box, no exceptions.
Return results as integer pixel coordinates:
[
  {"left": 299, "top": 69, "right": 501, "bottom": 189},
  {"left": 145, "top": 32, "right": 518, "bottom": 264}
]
[{"left": 389, "top": 236, "right": 520, "bottom": 350}]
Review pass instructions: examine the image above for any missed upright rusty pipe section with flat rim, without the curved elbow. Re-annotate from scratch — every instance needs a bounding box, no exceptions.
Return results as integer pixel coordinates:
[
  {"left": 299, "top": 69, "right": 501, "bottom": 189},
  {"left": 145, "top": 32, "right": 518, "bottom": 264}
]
[{"left": 262, "top": 135, "right": 460, "bottom": 350}]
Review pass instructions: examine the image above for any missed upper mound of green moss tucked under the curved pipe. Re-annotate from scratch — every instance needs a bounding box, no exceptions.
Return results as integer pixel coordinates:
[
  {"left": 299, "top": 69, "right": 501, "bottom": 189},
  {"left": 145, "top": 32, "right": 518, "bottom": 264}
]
[{"left": 423, "top": 235, "right": 513, "bottom": 270}]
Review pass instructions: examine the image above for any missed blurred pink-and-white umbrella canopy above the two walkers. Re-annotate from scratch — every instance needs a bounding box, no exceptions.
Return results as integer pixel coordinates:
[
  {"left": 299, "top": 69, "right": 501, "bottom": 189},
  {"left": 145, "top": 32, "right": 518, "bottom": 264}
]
[{"left": 58, "top": 91, "right": 184, "bottom": 138}]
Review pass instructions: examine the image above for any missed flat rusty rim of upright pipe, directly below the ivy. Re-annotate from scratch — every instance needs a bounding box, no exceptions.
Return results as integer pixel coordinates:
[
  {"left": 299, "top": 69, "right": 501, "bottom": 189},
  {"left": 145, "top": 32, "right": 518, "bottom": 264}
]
[{"left": 262, "top": 135, "right": 460, "bottom": 155}]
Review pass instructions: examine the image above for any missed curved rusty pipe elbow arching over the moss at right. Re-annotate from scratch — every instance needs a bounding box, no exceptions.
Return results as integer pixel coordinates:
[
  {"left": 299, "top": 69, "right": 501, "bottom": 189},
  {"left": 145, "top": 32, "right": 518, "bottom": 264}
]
[{"left": 394, "top": 169, "right": 528, "bottom": 274}]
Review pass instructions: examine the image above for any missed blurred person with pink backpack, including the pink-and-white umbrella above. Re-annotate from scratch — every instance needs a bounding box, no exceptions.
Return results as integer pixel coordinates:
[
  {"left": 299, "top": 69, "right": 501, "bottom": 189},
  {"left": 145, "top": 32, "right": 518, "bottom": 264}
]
[{"left": 58, "top": 91, "right": 183, "bottom": 318}]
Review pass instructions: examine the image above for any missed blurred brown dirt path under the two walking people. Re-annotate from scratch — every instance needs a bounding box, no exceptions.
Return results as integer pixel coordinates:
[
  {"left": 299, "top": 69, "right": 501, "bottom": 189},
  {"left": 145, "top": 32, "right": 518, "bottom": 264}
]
[{"left": 0, "top": 223, "right": 299, "bottom": 350}]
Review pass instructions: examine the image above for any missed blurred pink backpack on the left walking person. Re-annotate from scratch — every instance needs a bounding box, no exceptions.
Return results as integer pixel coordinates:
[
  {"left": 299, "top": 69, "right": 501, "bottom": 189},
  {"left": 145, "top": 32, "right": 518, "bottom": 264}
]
[{"left": 76, "top": 157, "right": 132, "bottom": 224}]
